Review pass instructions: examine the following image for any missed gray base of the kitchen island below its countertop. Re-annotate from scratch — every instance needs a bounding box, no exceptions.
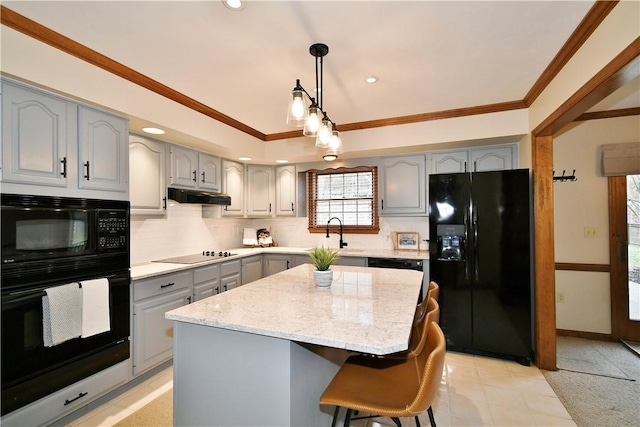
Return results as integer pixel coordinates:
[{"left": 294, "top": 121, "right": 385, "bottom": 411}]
[{"left": 173, "top": 322, "right": 348, "bottom": 426}]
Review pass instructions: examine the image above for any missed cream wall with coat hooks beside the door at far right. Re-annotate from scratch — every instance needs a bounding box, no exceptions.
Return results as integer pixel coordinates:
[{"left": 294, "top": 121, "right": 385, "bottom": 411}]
[{"left": 553, "top": 116, "right": 640, "bottom": 334}]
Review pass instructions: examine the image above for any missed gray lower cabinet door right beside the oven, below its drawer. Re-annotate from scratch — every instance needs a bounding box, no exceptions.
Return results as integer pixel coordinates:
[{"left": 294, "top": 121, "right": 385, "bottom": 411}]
[{"left": 133, "top": 288, "right": 191, "bottom": 376}]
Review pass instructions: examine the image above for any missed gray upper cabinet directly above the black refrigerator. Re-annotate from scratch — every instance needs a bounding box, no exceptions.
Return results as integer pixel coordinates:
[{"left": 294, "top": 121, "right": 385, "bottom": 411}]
[{"left": 429, "top": 144, "right": 517, "bottom": 174}]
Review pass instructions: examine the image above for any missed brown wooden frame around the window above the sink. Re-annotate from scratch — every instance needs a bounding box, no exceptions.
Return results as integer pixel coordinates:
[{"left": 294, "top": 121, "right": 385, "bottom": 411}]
[{"left": 307, "top": 166, "right": 380, "bottom": 234}]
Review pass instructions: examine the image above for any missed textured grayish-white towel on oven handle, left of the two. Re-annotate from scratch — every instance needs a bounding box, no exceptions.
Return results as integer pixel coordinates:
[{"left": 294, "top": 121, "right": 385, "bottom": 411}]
[{"left": 42, "top": 283, "right": 82, "bottom": 347}]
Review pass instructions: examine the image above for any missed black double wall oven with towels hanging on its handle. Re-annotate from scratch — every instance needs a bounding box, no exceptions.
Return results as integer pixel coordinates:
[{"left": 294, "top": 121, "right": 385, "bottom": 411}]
[{"left": 0, "top": 194, "right": 131, "bottom": 415}]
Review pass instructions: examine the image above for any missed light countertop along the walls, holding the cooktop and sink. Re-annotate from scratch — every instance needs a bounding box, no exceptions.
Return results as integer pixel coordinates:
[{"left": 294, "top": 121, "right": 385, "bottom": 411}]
[{"left": 131, "top": 246, "right": 429, "bottom": 280}]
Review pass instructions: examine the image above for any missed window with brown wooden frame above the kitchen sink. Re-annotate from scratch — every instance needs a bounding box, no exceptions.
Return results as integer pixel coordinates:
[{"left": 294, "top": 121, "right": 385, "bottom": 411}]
[{"left": 307, "top": 166, "right": 380, "bottom": 234}]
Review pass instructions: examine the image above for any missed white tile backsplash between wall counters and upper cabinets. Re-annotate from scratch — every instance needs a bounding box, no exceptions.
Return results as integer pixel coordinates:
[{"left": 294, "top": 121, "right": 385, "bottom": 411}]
[{"left": 131, "top": 203, "right": 429, "bottom": 265}]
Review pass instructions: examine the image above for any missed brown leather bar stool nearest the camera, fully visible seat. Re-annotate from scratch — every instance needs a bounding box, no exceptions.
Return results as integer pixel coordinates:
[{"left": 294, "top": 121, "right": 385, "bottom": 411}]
[{"left": 320, "top": 322, "right": 446, "bottom": 427}]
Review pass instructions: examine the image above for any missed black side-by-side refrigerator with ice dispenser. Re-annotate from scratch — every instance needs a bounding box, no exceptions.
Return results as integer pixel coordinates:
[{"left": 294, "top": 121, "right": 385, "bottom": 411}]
[{"left": 429, "top": 169, "right": 534, "bottom": 365}]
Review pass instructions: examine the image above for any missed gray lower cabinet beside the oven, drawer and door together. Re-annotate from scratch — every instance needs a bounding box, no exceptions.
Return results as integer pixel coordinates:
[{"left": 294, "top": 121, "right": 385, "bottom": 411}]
[{"left": 132, "top": 271, "right": 193, "bottom": 376}]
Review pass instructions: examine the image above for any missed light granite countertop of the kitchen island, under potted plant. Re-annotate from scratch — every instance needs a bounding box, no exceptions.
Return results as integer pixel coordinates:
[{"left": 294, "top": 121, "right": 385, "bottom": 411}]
[{"left": 165, "top": 264, "right": 422, "bottom": 354}]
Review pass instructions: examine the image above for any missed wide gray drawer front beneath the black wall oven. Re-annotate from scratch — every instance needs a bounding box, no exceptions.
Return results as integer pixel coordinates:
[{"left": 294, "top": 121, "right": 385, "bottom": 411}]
[{"left": 2, "top": 359, "right": 130, "bottom": 426}]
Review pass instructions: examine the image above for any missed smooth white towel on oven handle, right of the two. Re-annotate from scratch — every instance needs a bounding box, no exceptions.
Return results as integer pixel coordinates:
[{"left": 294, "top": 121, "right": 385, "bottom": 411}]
[{"left": 82, "top": 278, "right": 111, "bottom": 338}]
